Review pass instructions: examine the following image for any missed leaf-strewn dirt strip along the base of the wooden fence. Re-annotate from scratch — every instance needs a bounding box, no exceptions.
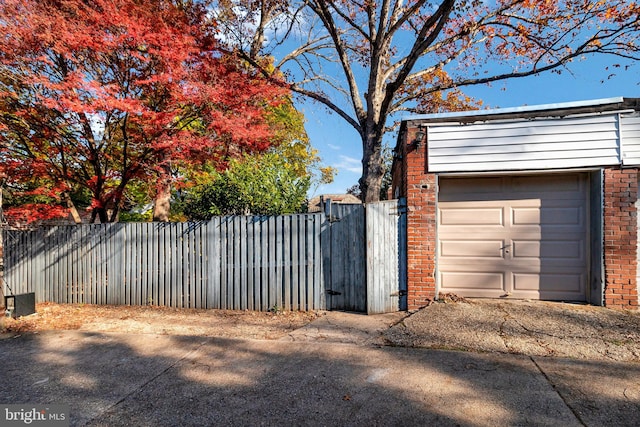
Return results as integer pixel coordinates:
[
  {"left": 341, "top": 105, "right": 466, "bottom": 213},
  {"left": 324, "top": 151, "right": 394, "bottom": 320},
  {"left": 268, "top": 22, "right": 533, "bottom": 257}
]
[{"left": 0, "top": 303, "right": 323, "bottom": 340}]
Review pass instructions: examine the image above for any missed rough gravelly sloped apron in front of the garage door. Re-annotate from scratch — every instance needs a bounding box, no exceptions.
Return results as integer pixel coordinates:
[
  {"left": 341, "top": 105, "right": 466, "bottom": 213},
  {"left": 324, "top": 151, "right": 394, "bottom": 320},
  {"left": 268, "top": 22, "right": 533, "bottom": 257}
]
[{"left": 384, "top": 298, "right": 640, "bottom": 361}]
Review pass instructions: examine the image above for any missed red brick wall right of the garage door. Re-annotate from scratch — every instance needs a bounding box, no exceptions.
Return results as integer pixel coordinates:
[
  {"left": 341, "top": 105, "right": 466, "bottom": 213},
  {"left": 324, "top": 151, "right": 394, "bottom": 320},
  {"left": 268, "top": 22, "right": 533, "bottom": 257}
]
[{"left": 603, "top": 168, "right": 638, "bottom": 309}]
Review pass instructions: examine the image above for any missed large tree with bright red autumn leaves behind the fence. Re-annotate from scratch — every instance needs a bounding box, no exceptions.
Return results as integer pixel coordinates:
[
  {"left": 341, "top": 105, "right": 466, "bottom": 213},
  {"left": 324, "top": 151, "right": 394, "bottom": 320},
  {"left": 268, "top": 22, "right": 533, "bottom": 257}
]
[{"left": 0, "top": 0, "right": 283, "bottom": 222}]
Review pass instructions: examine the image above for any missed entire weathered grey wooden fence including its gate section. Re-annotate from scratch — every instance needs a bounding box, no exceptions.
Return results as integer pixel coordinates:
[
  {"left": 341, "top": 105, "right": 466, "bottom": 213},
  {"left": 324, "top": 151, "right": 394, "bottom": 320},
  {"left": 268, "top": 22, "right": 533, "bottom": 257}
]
[{"left": 3, "top": 202, "right": 406, "bottom": 312}]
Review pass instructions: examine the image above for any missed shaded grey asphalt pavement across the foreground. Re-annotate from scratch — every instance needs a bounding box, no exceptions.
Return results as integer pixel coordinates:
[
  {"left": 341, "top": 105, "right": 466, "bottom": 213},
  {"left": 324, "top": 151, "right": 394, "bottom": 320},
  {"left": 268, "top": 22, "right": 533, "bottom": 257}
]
[{"left": 0, "top": 304, "right": 640, "bottom": 426}]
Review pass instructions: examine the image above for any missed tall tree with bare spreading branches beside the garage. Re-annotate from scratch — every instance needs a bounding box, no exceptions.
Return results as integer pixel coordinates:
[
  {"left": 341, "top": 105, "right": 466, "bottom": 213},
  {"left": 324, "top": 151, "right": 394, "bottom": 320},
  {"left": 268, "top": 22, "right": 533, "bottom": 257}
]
[{"left": 219, "top": 0, "right": 640, "bottom": 201}]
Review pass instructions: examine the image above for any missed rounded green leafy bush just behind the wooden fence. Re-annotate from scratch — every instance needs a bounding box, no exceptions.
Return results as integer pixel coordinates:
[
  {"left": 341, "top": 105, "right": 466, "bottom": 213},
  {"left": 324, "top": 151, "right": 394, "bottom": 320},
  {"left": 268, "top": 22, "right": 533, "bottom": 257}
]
[{"left": 184, "top": 153, "right": 310, "bottom": 220}]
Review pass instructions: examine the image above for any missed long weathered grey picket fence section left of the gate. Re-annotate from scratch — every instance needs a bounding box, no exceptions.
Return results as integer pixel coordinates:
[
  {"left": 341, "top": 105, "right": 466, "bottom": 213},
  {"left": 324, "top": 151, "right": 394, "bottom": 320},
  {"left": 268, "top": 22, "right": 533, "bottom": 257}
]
[{"left": 4, "top": 214, "right": 324, "bottom": 311}]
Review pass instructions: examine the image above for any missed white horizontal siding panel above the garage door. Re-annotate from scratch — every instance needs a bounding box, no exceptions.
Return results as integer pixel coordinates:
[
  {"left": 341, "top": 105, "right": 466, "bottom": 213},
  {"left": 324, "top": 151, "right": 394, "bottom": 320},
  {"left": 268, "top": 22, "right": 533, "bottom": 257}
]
[{"left": 427, "top": 114, "right": 624, "bottom": 172}]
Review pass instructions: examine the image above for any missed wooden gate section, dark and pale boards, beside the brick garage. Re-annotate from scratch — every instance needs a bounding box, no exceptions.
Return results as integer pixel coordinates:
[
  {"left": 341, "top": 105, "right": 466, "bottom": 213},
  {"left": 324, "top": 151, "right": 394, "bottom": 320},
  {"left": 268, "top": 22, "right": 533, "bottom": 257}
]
[{"left": 322, "top": 200, "right": 407, "bottom": 314}]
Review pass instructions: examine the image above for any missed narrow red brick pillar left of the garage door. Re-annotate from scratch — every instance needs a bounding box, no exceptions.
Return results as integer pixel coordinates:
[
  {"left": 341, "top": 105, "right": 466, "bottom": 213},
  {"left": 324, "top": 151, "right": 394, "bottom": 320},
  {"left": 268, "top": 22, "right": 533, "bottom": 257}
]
[{"left": 403, "top": 129, "right": 437, "bottom": 310}]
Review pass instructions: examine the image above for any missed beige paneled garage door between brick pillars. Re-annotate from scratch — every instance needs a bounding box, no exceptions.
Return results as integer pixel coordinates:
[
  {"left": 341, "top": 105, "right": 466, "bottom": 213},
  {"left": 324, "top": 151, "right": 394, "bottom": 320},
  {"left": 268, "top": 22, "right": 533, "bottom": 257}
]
[{"left": 438, "top": 174, "right": 588, "bottom": 301}]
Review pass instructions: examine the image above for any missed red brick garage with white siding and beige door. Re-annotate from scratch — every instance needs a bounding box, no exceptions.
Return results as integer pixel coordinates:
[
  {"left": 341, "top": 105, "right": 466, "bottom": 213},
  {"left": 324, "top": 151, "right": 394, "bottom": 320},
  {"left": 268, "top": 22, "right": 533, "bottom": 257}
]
[{"left": 390, "top": 98, "right": 640, "bottom": 310}]
